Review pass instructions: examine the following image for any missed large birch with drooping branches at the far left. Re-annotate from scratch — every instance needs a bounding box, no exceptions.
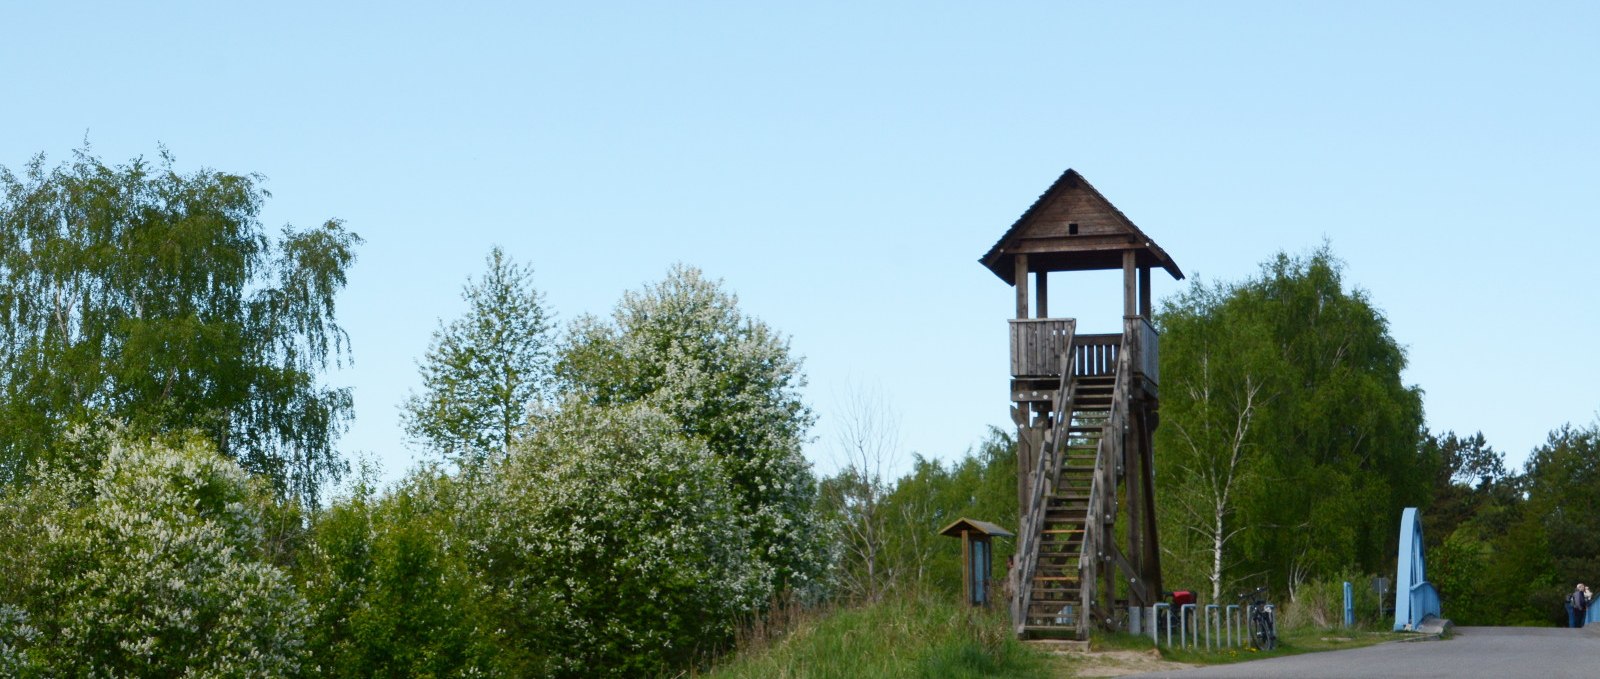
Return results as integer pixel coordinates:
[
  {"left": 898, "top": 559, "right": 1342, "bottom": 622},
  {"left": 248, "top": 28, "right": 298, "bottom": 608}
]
[{"left": 0, "top": 151, "right": 360, "bottom": 501}]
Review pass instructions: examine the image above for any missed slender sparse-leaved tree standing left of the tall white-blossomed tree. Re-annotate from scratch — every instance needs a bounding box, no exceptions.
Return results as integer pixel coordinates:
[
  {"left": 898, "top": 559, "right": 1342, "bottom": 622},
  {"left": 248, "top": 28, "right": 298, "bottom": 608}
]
[{"left": 402, "top": 247, "right": 554, "bottom": 463}]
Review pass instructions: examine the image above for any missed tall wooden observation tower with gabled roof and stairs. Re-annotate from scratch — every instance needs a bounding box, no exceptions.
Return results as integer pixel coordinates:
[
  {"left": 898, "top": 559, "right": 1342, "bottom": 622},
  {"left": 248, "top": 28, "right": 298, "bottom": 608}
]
[{"left": 979, "top": 170, "right": 1184, "bottom": 639}]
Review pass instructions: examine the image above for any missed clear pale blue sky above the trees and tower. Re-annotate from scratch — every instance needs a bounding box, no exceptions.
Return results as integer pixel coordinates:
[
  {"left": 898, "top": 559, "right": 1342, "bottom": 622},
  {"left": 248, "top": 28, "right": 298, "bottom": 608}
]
[{"left": 0, "top": 2, "right": 1600, "bottom": 486}]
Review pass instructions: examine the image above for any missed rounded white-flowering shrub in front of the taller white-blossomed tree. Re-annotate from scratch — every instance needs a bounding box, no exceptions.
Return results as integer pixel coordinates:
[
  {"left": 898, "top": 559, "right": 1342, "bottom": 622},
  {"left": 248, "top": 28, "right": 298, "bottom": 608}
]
[{"left": 474, "top": 404, "right": 762, "bottom": 677}]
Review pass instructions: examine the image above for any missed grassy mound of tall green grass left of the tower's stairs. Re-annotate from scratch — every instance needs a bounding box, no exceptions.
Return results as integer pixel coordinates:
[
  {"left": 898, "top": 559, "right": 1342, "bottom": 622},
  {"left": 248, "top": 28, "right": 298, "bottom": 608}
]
[{"left": 704, "top": 593, "right": 1050, "bottom": 679}]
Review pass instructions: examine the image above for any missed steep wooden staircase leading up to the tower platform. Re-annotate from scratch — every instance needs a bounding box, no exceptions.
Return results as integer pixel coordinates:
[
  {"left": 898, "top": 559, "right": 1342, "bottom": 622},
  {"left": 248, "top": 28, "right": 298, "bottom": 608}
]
[{"left": 1019, "top": 375, "right": 1115, "bottom": 639}]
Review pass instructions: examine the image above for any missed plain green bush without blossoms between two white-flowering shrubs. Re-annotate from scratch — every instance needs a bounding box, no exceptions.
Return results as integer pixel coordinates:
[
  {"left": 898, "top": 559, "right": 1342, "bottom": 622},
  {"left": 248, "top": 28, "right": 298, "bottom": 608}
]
[{"left": 298, "top": 466, "right": 499, "bottom": 677}]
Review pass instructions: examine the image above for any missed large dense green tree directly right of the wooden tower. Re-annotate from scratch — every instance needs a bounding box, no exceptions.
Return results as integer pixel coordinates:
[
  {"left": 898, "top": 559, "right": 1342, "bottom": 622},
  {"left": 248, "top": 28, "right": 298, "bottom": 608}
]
[{"left": 1157, "top": 247, "right": 1432, "bottom": 594}]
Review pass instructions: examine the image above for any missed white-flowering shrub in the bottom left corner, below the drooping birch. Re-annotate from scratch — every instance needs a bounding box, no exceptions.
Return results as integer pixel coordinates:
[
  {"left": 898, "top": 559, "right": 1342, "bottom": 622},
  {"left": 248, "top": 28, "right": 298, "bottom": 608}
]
[{"left": 0, "top": 444, "right": 310, "bottom": 677}]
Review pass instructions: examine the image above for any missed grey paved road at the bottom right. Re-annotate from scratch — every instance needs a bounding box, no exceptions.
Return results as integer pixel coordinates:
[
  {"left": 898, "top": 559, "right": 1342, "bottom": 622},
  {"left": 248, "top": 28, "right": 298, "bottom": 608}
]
[{"left": 1138, "top": 625, "right": 1600, "bottom": 679}]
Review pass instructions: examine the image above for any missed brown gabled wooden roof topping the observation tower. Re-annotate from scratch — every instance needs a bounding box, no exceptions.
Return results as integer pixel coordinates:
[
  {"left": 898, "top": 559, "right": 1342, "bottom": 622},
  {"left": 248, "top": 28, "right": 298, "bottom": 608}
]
[{"left": 978, "top": 168, "right": 1184, "bottom": 285}]
